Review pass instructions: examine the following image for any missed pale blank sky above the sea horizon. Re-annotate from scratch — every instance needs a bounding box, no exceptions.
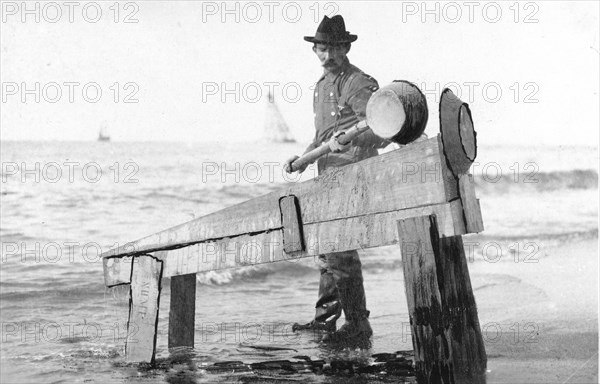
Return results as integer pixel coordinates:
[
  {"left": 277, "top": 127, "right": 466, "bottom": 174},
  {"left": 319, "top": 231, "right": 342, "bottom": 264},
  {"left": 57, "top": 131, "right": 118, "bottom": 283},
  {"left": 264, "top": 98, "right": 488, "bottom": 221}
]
[{"left": 0, "top": 1, "right": 600, "bottom": 145}]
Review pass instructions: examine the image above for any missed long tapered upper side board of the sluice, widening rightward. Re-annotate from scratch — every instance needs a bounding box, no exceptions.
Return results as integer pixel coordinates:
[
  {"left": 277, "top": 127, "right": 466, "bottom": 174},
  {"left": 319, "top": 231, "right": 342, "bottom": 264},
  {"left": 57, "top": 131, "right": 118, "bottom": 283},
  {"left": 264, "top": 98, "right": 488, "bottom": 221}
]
[{"left": 102, "top": 136, "right": 458, "bottom": 257}]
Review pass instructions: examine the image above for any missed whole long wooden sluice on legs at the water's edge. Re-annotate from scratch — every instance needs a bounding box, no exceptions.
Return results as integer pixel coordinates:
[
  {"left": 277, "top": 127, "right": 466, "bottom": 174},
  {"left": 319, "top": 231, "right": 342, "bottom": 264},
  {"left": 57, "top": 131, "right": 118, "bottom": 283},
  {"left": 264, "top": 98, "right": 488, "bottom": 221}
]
[{"left": 102, "top": 83, "right": 487, "bottom": 383}]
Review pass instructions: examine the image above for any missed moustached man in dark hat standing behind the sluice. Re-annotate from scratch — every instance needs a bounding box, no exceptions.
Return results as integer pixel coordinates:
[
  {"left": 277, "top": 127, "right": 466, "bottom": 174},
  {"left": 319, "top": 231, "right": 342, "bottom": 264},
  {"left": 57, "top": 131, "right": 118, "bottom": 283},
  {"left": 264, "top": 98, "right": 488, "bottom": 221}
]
[{"left": 286, "top": 15, "right": 389, "bottom": 342}]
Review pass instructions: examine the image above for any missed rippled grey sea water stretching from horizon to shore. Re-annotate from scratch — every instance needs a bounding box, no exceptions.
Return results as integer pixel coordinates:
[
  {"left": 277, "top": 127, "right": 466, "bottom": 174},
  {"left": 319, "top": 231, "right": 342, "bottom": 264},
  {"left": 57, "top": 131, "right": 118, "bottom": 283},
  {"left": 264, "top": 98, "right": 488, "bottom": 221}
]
[{"left": 0, "top": 142, "right": 598, "bottom": 383}]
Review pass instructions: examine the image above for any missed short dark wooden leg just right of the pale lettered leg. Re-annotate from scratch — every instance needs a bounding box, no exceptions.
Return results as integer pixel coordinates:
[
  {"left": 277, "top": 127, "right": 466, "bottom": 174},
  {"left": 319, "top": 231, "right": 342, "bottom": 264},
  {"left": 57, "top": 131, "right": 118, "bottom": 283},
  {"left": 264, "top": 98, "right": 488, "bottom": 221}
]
[{"left": 169, "top": 273, "right": 196, "bottom": 348}]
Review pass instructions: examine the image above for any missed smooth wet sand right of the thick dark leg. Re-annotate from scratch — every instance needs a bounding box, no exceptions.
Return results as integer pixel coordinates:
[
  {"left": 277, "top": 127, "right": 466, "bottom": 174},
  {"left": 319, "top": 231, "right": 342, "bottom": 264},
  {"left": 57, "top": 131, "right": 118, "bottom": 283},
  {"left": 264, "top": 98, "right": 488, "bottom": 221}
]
[{"left": 469, "top": 239, "right": 598, "bottom": 383}]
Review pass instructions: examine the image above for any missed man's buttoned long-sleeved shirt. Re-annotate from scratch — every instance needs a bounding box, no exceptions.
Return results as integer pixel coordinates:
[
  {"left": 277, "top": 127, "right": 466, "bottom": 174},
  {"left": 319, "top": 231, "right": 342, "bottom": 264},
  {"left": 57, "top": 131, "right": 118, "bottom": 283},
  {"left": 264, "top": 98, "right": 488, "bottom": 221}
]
[{"left": 305, "top": 59, "right": 390, "bottom": 173}]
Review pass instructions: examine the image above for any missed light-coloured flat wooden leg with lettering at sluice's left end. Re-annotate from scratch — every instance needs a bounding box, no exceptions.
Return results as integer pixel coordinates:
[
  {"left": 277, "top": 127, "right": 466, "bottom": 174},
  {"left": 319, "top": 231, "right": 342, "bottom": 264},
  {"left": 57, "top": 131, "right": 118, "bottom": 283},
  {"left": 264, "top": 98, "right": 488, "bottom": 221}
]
[{"left": 125, "top": 255, "right": 163, "bottom": 363}]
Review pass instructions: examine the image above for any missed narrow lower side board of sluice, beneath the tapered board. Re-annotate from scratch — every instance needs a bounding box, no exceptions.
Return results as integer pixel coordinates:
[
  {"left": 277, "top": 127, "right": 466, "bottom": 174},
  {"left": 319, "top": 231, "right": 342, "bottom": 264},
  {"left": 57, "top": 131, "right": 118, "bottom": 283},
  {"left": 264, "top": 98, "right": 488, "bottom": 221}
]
[{"left": 104, "top": 200, "right": 474, "bottom": 286}]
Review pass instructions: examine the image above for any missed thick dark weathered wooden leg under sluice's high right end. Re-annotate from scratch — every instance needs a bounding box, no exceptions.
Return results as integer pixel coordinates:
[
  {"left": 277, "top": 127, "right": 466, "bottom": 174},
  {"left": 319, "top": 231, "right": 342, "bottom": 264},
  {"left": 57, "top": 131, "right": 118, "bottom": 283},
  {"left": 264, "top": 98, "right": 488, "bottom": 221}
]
[{"left": 398, "top": 215, "right": 487, "bottom": 383}]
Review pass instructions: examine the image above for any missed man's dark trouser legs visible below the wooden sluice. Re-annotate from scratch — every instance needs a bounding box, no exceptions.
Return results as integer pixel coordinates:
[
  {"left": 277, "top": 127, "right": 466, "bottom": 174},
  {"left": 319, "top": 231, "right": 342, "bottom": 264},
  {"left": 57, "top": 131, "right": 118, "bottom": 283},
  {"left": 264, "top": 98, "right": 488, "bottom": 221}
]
[{"left": 315, "top": 251, "right": 369, "bottom": 323}]
